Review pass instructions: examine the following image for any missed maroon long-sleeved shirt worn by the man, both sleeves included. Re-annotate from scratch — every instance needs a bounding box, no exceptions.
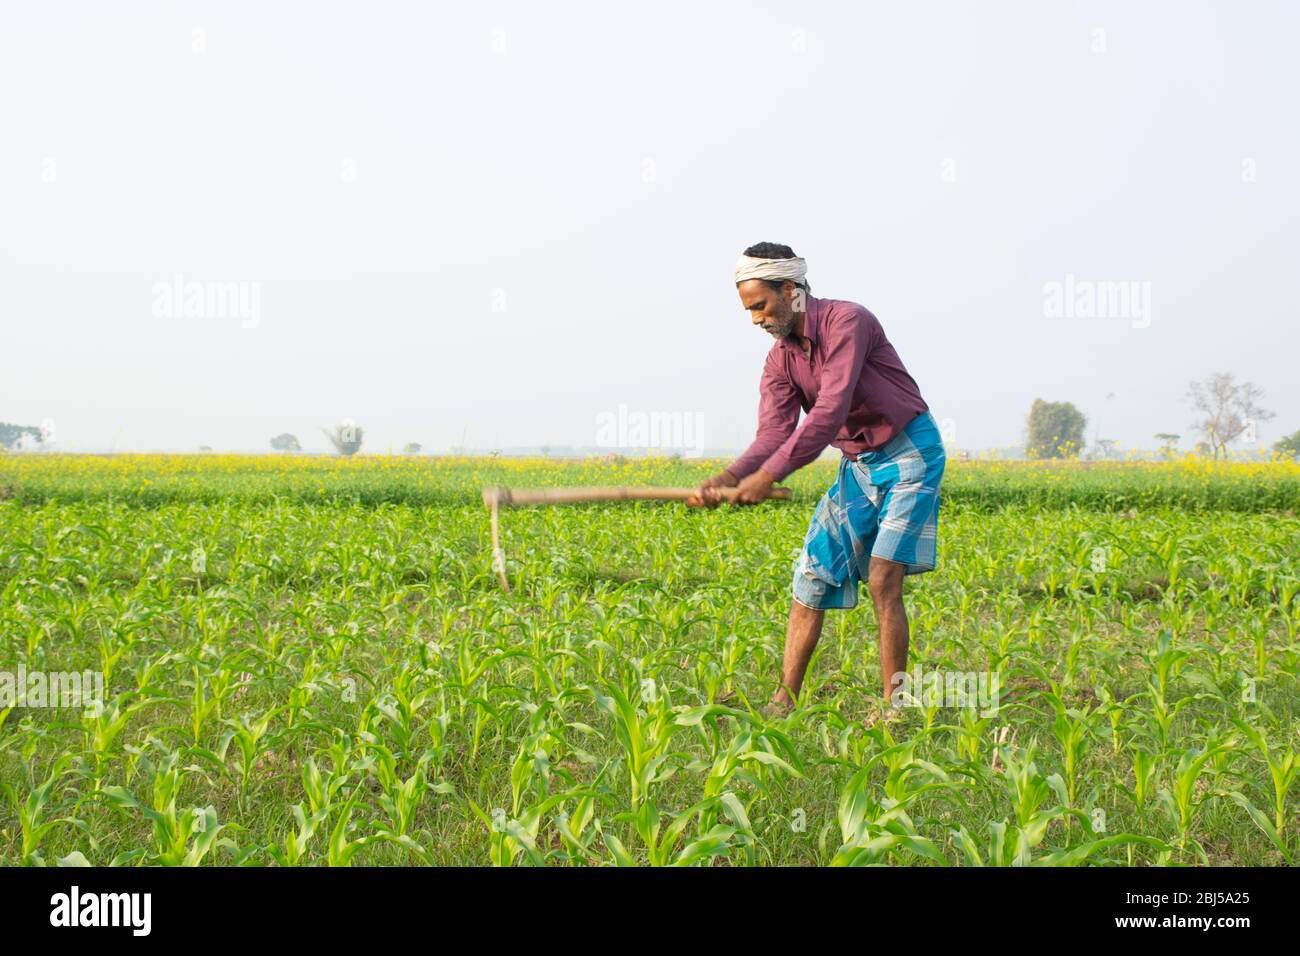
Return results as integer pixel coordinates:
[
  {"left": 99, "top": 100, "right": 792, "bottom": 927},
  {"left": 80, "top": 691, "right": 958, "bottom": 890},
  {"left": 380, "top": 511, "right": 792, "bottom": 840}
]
[{"left": 728, "top": 295, "right": 930, "bottom": 481}]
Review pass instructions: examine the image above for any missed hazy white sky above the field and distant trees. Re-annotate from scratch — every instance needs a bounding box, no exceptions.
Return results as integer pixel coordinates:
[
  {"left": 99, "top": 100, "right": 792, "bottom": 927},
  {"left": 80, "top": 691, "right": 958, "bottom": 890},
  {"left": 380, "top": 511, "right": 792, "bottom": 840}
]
[{"left": 0, "top": 0, "right": 1300, "bottom": 451}]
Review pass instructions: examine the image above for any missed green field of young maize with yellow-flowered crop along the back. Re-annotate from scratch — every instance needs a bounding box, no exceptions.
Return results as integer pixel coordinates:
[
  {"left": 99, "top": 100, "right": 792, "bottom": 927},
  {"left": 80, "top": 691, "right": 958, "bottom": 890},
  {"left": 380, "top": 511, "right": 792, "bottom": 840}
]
[{"left": 0, "top": 455, "right": 1300, "bottom": 866}]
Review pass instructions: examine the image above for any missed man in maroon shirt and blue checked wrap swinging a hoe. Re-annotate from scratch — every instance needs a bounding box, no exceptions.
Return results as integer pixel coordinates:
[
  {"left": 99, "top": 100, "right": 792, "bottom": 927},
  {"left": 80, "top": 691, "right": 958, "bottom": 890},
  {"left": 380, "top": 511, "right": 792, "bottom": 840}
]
[{"left": 688, "top": 242, "right": 946, "bottom": 717}]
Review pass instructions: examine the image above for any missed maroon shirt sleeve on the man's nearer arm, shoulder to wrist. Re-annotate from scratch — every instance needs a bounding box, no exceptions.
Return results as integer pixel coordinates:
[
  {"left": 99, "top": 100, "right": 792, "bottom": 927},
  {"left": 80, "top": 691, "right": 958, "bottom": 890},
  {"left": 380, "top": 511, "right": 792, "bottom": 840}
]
[{"left": 761, "top": 310, "right": 875, "bottom": 481}]
